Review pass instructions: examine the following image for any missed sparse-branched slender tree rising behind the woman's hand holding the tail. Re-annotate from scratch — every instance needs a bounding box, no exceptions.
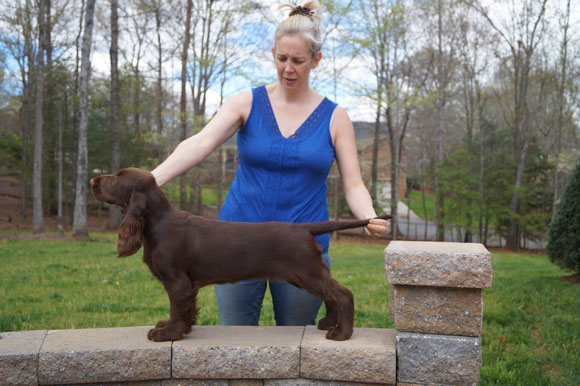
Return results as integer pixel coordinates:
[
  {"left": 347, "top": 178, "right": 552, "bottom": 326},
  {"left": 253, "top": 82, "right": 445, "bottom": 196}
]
[{"left": 361, "top": 0, "right": 430, "bottom": 239}]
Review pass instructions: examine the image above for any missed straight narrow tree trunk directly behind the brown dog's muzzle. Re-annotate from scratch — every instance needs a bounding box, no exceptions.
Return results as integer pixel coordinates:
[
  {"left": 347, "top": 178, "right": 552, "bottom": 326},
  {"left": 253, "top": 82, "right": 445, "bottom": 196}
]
[{"left": 107, "top": 0, "right": 121, "bottom": 229}]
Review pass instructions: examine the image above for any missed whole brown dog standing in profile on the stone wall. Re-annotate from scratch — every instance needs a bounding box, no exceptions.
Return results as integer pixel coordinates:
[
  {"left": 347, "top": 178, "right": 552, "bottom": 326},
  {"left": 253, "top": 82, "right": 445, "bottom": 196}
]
[{"left": 91, "top": 168, "right": 392, "bottom": 342}]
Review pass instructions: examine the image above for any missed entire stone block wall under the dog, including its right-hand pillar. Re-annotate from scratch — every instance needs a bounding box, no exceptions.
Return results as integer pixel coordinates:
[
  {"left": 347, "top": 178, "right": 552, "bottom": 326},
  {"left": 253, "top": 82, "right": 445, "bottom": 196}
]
[{"left": 0, "top": 241, "right": 491, "bottom": 386}]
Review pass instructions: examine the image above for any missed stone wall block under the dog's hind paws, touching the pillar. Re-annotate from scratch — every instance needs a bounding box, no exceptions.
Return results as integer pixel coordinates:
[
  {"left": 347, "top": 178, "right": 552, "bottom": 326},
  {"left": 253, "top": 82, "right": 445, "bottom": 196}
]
[{"left": 300, "top": 326, "right": 396, "bottom": 384}]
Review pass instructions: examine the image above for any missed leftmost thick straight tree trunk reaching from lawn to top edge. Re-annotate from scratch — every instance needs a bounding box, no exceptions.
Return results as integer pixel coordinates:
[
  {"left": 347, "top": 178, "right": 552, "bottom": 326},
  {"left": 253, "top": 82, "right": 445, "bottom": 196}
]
[{"left": 32, "top": 0, "right": 46, "bottom": 233}]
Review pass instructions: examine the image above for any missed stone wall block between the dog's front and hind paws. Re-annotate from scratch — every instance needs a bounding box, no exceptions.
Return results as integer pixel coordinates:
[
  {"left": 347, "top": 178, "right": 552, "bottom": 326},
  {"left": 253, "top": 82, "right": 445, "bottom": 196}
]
[{"left": 173, "top": 326, "right": 304, "bottom": 379}]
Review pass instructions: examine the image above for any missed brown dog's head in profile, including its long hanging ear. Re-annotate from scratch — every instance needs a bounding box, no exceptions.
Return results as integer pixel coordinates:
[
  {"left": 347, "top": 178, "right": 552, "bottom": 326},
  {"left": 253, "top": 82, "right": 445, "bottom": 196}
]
[{"left": 90, "top": 168, "right": 162, "bottom": 257}]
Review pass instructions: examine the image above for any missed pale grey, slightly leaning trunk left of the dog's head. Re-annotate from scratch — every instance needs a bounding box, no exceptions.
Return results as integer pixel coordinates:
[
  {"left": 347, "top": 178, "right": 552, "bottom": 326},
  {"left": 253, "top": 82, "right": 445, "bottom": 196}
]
[{"left": 73, "top": 0, "right": 95, "bottom": 237}]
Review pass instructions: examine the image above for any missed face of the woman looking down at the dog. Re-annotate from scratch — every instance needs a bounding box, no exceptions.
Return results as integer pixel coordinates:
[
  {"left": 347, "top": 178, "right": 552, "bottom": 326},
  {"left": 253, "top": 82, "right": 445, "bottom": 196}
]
[{"left": 272, "top": 34, "right": 322, "bottom": 91}]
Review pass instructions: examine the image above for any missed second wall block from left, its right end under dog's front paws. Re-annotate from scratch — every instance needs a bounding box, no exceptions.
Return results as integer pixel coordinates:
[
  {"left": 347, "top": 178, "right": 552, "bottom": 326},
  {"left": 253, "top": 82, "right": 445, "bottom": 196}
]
[{"left": 38, "top": 327, "right": 171, "bottom": 385}]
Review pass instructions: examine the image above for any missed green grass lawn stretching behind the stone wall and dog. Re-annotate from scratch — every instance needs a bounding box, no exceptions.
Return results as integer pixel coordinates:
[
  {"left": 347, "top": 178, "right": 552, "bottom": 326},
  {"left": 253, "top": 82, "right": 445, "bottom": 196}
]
[{"left": 0, "top": 237, "right": 580, "bottom": 385}]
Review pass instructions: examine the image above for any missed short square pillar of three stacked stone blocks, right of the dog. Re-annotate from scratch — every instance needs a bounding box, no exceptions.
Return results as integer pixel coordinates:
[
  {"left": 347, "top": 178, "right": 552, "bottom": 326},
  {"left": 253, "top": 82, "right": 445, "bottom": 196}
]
[{"left": 385, "top": 241, "right": 492, "bottom": 385}]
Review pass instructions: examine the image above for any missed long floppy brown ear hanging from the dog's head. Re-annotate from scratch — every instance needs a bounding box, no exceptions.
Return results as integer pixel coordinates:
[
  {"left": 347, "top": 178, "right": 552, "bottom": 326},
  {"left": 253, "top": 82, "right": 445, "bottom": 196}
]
[{"left": 117, "top": 192, "right": 146, "bottom": 257}]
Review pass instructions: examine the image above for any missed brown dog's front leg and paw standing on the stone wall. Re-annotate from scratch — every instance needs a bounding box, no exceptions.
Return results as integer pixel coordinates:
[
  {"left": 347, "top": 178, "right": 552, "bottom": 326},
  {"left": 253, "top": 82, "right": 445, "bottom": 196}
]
[{"left": 147, "top": 277, "right": 197, "bottom": 342}]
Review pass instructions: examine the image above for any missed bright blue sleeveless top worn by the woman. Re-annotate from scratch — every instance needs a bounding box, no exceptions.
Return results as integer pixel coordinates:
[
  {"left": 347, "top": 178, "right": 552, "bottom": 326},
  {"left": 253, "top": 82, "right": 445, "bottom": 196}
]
[{"left": 218, "top": 86, "right": 336, "bottom": 252}]
